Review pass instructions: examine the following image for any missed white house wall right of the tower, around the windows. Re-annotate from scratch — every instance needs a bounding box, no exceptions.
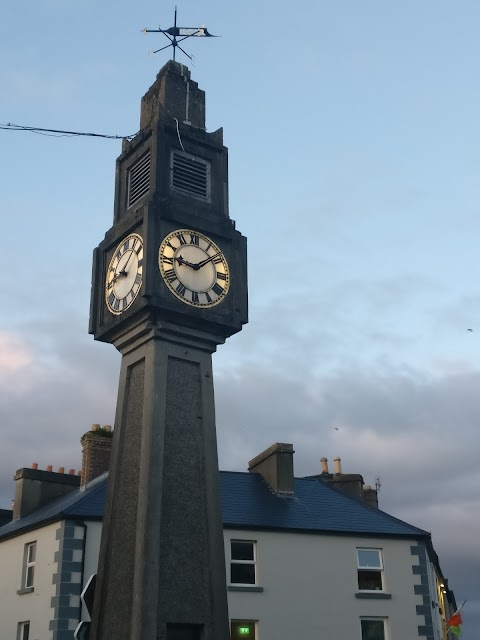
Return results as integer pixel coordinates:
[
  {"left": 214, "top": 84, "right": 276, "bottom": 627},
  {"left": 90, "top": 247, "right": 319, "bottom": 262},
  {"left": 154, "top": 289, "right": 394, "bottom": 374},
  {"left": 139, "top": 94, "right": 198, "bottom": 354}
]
[{"left": 224, "top": 530, "right": 428, "bottom": 640}]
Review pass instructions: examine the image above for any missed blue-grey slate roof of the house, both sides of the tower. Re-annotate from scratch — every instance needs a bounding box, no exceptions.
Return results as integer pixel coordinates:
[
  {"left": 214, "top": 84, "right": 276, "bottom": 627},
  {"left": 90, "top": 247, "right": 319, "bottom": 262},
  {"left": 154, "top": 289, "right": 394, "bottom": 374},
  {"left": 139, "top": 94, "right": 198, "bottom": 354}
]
[{"left": 0, "top": 471, "right": 429, "bottom": 539}]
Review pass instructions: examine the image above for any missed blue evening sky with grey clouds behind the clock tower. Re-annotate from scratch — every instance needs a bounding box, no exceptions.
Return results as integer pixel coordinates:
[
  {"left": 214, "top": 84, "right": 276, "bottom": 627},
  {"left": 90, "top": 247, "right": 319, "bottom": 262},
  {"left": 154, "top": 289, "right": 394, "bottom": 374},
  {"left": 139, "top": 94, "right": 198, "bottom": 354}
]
[{"left": 0, "top": 0, "right": 480, "bottom": 640}]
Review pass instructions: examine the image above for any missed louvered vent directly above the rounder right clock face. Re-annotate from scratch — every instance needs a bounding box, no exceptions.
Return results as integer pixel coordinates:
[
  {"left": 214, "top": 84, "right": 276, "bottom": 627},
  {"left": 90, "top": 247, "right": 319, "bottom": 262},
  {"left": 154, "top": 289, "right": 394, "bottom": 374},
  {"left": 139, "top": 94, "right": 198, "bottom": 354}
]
[{"left": 170, "top": 151, "right": 210, "bottom": 200}]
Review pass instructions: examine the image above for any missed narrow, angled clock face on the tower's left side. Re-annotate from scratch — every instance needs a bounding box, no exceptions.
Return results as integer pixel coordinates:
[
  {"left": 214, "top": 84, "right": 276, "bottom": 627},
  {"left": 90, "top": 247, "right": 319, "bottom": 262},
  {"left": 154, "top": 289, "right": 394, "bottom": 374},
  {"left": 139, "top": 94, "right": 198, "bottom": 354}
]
[{"left": 105, "top": 233, "right": 143, "bottom": 316}]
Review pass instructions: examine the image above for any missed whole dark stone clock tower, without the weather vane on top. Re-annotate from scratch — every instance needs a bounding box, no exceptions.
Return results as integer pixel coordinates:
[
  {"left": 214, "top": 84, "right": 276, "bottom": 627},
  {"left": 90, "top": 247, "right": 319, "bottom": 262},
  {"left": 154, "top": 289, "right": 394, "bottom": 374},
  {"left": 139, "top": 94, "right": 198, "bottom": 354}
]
[{"left": 90, "top": 61, "right": 247, "bottom": 640}]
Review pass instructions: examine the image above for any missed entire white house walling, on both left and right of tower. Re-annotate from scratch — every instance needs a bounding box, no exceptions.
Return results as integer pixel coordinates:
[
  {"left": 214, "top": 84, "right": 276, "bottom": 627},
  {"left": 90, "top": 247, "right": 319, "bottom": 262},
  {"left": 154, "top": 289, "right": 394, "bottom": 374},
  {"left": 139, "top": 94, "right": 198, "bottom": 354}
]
[{"left": 0, "top": 522, "right": 433, "bottom": 640}]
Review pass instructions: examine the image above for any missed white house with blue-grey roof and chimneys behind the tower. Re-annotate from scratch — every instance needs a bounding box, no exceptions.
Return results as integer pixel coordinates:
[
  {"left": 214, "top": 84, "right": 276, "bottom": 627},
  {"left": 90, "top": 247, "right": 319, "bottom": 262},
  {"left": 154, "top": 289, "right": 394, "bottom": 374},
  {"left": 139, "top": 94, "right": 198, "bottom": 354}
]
[{"left": 0, "top": 425, "right": 455, "bottom": 640}]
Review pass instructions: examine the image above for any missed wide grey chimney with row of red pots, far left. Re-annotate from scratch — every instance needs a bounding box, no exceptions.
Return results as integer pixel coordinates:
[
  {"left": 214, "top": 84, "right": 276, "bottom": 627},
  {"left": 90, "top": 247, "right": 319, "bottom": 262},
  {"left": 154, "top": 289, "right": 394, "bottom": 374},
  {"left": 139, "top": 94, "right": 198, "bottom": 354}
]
[{"left": 13, "top": 465, "right": 80, "bottom": 519}]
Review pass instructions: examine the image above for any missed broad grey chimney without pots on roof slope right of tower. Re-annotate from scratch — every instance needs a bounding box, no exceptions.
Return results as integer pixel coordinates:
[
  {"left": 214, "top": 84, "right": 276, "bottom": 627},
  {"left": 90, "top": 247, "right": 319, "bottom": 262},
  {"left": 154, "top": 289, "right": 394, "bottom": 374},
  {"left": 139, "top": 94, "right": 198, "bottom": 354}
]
[{"left": 248, "top": 442, "right": 294, "bottom": 495}]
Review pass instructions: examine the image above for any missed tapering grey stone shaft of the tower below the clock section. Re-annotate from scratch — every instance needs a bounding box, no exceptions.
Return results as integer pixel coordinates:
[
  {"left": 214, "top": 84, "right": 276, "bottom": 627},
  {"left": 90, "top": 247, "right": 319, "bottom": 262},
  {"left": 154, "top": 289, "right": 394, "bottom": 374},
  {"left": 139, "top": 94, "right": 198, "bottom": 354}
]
[{"left": 91, "top": 322, "right": 230, "bottom": 640}]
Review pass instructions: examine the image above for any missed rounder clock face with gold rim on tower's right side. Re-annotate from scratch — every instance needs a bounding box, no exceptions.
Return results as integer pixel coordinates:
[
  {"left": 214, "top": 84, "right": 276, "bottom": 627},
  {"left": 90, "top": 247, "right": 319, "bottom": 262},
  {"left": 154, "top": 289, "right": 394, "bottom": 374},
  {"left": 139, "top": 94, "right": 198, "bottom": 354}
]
[{"left": 158, "top": 229, "right": 230, "bottom": 308}]
